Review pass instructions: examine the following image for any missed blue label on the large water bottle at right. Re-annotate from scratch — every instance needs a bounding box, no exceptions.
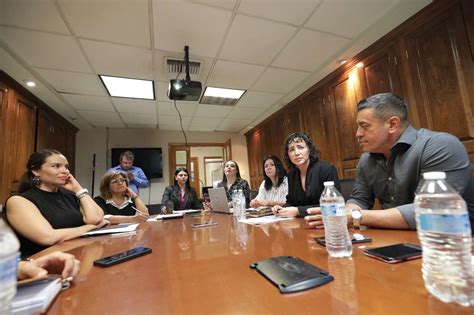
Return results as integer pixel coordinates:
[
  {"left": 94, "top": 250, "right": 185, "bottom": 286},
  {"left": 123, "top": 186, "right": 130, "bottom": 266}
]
[{"left": 418, "top": 213, "right": 471, "bottom": 234}]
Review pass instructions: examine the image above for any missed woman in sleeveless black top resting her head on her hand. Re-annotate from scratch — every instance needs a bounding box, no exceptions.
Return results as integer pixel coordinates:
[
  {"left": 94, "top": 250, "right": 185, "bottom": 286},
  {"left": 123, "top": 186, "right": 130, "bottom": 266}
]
[{"left": 5, "top": 149, "right": 107, "bottom": 257}]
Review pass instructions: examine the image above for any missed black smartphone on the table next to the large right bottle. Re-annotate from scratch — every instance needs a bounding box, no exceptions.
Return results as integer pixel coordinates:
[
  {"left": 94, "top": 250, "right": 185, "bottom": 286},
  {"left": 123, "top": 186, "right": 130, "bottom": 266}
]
[{"left": 364, "top": 243, "right": 421, "bottom": 264}]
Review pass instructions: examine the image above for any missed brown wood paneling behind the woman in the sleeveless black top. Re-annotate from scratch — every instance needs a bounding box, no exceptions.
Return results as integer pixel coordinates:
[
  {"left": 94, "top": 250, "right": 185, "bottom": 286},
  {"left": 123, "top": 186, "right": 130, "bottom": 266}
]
[{"left": 0, "top": 70, "right": 78, "bottom": 204}]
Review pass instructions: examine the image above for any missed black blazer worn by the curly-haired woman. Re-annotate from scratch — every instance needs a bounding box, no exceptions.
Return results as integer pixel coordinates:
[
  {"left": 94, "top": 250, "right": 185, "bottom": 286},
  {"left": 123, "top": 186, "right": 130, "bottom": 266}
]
[{"left": 285, "top": 161, "right": 341, "bottom": 217}]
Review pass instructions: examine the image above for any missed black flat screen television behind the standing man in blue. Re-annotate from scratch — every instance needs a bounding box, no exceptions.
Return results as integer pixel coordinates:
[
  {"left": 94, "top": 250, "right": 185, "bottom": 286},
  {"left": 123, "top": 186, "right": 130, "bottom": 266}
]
[{"left": 111, "top": 148, "right": 163, "bottom": 179}]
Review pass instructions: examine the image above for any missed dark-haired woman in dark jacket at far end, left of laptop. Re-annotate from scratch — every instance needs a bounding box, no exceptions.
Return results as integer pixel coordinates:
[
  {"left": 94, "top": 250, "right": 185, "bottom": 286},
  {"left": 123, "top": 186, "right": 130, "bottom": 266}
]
[{"left": 161, "top": 167, "right": 202, "bottom": 214}]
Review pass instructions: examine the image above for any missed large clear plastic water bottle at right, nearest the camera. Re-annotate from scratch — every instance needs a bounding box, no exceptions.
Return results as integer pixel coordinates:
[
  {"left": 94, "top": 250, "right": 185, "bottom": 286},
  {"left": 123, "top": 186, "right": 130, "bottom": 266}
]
[{"left": 415, "top": 172, "right": 474, "bottom": 306}]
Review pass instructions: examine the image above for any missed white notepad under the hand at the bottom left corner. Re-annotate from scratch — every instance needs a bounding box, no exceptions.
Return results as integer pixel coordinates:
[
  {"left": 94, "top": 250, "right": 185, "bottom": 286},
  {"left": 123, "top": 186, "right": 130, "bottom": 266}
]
[{"left": 11, "top": 276, "right": 64, "bottom": 315}]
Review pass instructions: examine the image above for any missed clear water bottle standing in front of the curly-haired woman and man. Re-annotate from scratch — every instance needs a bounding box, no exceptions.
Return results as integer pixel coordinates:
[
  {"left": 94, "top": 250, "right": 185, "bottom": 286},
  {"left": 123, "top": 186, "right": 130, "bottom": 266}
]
[{"left": 319, "top": 182, "right": 352, "bottom": 257}]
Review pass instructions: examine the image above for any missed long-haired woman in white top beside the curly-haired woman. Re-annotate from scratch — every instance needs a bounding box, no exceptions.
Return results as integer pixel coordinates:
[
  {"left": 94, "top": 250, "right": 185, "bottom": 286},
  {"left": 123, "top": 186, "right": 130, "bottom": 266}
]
[{"left": 250, "top": 155, "right": 288, "bottom": 208}]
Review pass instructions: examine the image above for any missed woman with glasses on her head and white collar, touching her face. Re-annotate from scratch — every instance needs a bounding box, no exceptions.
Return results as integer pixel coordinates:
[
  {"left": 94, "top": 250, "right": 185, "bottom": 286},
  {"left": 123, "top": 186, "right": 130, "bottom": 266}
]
[{"left": 94, "top": 172, "right": 150, "bottom": 224}]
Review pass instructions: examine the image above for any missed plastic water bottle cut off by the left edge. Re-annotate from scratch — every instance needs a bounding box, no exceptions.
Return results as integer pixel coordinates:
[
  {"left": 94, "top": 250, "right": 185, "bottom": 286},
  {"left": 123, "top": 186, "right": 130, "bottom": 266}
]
[{"left": 0, "top": 206, "right": 20, "bottom": 315}]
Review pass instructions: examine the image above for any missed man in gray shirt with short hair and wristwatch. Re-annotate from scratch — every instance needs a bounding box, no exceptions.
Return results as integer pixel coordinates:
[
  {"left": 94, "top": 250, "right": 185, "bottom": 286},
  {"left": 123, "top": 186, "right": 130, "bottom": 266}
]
[{"left": 305, "top": 93, "right": 474, "bottom": 230}]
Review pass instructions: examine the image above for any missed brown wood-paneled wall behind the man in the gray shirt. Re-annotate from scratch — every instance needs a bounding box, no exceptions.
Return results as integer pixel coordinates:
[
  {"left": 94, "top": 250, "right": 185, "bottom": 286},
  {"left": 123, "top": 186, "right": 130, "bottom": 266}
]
[{"left": 246, "top": 0, "right": 474, "bottom": 188}]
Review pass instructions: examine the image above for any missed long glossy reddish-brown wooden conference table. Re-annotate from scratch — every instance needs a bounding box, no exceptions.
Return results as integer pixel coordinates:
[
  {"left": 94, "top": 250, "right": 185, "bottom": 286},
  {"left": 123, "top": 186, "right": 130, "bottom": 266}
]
[{"left": 35, "top": 213, "right": 474, "bottom": 315}]
